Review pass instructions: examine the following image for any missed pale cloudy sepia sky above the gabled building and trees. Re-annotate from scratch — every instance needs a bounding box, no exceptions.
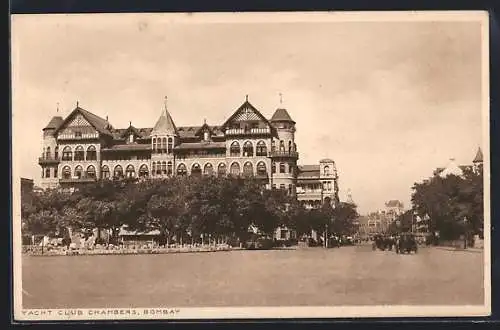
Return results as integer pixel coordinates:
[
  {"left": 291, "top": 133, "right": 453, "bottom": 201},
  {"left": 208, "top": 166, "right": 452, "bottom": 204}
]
[{"left": 11, "top": 14, "right": 486, "bottom": 213}]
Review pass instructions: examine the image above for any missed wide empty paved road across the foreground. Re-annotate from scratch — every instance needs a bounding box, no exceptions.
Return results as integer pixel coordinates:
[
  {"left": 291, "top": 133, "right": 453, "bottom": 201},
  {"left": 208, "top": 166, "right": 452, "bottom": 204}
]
[{"left": 23, "top": 246, "right": 484, "bottom": 308}]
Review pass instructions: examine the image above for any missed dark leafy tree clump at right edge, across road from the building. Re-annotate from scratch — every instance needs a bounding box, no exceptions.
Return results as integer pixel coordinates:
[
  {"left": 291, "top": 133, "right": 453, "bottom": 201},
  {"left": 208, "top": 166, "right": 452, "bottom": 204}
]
[{"left": 410, "top": 169, "right": 484, "bottom": 240}]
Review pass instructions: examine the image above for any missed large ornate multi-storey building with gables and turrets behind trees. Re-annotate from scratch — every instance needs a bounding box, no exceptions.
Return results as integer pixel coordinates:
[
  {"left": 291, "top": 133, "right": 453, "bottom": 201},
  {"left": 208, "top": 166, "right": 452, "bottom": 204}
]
[{"left": 38, "top": 97, "right": 338, "bottom": 207}]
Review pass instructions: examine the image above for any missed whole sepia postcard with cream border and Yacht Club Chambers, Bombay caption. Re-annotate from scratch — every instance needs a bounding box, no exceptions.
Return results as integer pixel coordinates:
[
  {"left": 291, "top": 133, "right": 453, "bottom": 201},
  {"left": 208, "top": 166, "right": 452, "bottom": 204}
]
[{"left": 11, "top": 11, "right": 491, "bottom": 321}]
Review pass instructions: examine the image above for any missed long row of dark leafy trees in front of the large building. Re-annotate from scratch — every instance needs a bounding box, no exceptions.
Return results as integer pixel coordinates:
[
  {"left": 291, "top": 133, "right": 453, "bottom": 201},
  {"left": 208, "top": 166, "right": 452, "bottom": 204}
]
[{"left": 22, "top": 176, "right": 357, "bottom": 243}]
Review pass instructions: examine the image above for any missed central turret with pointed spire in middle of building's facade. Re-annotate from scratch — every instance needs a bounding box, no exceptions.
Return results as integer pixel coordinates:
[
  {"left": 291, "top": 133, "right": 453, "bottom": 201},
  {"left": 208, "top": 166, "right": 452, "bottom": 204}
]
[{"left": 150, "top": 96, "right": 179, "bottom": 177}]
